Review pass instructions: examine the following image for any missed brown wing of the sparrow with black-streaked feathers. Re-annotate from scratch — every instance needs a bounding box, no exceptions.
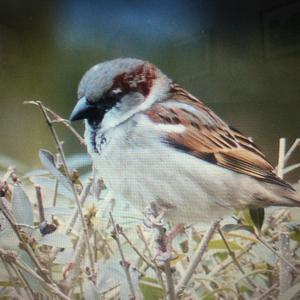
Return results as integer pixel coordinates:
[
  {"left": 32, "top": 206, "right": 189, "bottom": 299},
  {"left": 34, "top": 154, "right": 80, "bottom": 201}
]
[{"left": 146, "top": 85, "right": 291, "bottom": 188}]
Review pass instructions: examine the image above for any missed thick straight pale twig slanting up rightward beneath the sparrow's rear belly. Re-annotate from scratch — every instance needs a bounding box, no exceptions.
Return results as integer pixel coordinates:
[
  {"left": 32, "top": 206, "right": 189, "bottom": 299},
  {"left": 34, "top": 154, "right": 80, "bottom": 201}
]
[{"left": 176, "top": 220, "right": 220, "bottom": 295}]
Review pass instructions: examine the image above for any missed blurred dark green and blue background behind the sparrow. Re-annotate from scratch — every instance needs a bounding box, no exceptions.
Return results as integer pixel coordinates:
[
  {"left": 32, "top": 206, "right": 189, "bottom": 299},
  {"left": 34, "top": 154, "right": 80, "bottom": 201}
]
[{"left": 0, "top": 0, "right": 300, "bottom": 178}]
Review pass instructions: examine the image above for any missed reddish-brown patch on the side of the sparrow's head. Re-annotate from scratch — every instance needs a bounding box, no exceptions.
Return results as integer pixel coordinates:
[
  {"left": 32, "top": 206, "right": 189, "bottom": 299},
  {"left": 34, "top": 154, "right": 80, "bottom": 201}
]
[{"left": 111, "top": 62, "right": 157, "bottom": 97}]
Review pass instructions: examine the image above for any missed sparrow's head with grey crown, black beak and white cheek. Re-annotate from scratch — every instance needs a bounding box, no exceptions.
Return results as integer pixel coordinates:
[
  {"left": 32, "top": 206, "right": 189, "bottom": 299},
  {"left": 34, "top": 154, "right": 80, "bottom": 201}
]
[{"left": 70, "top": 58, "right": 170, "bottom": 128}]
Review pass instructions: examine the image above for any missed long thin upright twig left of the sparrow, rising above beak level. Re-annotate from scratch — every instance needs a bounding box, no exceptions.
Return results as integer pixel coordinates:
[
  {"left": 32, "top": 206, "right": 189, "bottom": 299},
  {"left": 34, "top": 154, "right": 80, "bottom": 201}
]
[{"left": 36, "top": 101, "right": 95, "bottom": 273}]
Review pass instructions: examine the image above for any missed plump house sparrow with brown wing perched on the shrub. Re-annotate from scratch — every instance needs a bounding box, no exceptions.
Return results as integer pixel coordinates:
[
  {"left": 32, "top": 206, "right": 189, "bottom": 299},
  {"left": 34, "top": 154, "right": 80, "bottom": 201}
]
[{"left": 70, "top": 58, "right": 300, "bottom": 223}]
